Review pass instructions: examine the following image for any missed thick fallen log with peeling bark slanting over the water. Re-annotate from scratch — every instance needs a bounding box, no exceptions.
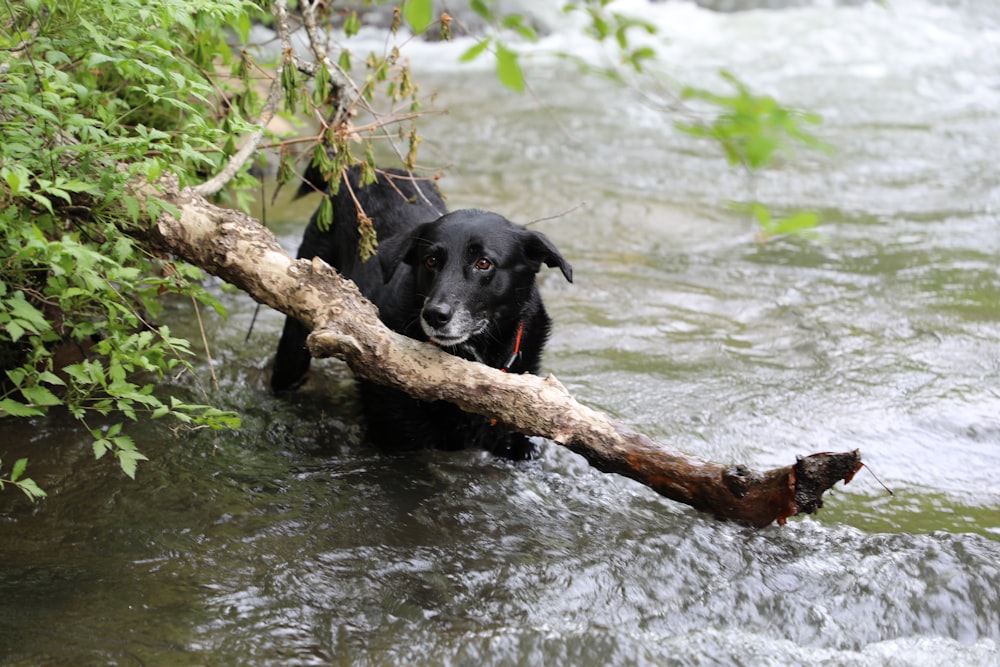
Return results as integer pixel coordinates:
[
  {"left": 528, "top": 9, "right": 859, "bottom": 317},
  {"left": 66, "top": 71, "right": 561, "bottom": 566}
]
[{"left": 144, "top": 179, "right": 862, "bottom": 527}]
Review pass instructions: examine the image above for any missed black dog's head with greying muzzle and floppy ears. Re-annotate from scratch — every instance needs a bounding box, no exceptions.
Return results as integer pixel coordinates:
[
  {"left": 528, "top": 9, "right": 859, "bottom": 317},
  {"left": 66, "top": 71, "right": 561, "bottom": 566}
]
[{"left": 378, "top": 210, "right": 573, "bottom": 347}]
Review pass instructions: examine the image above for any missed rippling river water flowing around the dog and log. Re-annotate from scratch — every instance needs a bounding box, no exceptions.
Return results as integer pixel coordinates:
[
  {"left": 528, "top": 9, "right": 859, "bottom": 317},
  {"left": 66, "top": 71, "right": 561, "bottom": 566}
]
[{"left": 0, "top": 0, "right": 1000, "bottom": 666}]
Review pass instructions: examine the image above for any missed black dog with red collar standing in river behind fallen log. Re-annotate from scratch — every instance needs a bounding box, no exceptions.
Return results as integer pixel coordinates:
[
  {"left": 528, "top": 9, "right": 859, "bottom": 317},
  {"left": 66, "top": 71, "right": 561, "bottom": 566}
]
[{"left": 271, "top": 170, "right": 573, "bottom": 459}]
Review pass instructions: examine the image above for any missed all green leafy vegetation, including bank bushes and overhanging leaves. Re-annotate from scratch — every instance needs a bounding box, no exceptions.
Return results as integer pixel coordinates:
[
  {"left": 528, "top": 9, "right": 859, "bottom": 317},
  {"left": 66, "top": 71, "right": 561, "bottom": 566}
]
[{"left": 0, "top": 0, "right": 836, "bottom": 512}]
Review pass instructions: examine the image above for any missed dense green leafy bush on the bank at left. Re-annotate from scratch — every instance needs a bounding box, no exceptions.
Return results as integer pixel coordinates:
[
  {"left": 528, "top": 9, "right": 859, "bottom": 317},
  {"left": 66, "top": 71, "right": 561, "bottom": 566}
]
[{"left": 0, "top": 0, "right": 255, "bottom": 490}]
